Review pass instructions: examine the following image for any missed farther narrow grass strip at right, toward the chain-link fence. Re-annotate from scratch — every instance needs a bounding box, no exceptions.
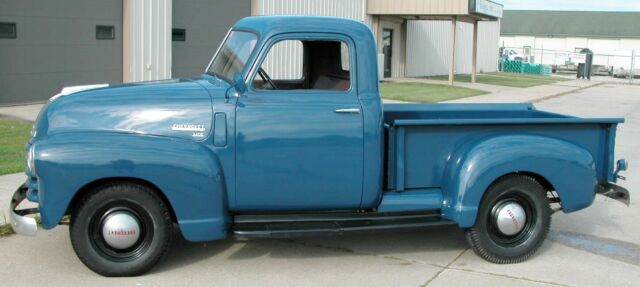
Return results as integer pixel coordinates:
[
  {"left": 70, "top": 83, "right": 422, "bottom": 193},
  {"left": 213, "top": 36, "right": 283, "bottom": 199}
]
[{"left": 429, "top": 72, "right": 569, "bottom": 88}]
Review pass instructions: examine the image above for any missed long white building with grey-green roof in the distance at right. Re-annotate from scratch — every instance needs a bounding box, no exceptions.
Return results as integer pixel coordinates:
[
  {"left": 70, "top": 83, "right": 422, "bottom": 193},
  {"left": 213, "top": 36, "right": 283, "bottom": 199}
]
[{"left": 500, "top": 11, "right": 640, "bottom": 69}]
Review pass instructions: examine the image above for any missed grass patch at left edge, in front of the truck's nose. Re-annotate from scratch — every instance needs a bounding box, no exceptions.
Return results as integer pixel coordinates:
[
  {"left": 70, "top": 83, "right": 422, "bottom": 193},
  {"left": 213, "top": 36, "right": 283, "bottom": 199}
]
[{"left": 0, "top": 120, "right": 32, "bottom": 175}]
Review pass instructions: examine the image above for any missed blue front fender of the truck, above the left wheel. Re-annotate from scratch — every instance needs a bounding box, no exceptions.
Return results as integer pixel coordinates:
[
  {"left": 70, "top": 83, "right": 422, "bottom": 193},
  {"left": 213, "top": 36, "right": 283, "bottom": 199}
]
[{"left": 36, "top": 132, "right": 230, "bottom": 241}]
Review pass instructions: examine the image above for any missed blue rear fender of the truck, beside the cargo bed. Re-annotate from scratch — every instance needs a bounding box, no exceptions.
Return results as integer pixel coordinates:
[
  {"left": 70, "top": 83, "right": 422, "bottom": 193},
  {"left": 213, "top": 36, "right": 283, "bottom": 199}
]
[{"left": 442, "top": 134, "right": 597, "bottom": 228}]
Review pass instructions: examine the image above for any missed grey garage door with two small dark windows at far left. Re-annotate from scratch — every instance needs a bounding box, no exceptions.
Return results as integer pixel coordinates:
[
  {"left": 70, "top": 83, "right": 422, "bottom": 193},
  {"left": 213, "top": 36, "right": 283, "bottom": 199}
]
[{"left": 0, "top": 0, "right": 123, "bottom": 105}]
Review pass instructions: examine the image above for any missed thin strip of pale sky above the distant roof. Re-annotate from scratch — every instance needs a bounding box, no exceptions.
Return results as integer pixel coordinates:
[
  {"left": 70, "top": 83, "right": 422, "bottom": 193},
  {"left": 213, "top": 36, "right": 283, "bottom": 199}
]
[{"left": 493, "top": 0, "right": 640, "bottom": 11}]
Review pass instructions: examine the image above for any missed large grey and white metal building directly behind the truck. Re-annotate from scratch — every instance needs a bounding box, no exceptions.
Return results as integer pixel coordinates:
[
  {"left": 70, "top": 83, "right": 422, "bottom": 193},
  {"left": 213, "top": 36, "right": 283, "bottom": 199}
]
[{"left": 0, "top": 0, "right": 502, "bottom": 105}]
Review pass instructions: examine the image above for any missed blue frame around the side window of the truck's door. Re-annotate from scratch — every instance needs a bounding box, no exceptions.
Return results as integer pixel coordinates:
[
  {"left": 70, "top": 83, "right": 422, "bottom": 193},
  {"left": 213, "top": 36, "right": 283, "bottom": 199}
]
[{"left": 245, "top": 32, "right": 358, "bottom": 94}]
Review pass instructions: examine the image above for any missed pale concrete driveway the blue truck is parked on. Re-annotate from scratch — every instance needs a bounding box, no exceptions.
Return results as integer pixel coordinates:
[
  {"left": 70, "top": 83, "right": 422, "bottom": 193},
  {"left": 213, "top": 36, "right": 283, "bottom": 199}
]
[{"left": 0, "top": 84, "right": 640, "bottom": 286}]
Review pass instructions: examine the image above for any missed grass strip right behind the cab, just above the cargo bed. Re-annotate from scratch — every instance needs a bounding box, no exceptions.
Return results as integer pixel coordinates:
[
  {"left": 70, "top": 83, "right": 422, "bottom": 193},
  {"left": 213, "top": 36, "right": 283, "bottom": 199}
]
[{"left": 380, "top": 82, "right": 487, "bottom": 103}]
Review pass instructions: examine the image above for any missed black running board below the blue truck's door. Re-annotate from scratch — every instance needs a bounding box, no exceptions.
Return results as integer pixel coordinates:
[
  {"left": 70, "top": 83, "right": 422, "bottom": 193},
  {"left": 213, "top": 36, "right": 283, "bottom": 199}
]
[{"left": 233, "top": 211, "right": 455, "bottom": 238}]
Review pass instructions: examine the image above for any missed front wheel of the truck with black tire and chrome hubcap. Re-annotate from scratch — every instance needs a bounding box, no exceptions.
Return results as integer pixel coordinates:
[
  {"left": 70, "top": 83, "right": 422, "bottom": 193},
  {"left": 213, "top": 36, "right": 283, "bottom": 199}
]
[{"left": 69, "top": 183, "right": 173, "bottom": 276}]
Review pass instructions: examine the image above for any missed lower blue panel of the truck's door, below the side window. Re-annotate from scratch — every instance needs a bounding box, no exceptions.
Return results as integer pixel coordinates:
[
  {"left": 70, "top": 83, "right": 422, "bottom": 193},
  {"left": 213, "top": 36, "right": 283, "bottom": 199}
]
[{"left": 236, "top": 36, "right": 363, "bottom": 211}]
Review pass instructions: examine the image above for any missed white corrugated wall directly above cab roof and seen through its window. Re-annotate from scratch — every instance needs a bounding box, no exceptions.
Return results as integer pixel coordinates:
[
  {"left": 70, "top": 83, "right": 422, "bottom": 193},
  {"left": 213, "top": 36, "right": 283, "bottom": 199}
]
[{"left": 252, "top": 0, "right": 371, "bottom": 79}]
